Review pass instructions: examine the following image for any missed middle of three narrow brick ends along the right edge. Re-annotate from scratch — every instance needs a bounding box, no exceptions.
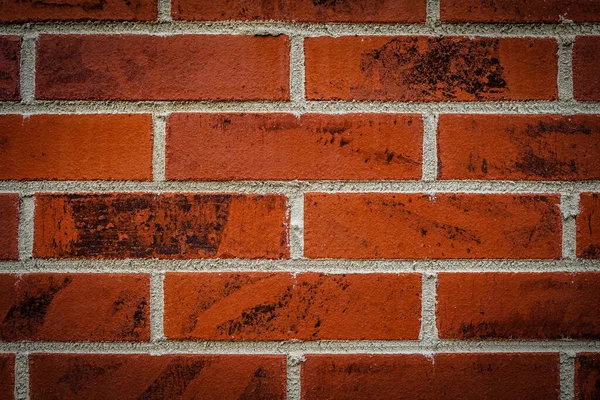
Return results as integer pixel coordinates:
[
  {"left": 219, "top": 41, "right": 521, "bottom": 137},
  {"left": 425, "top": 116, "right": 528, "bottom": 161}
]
[{"left": 577, "top": 193, "right": 600, "bottom": 258}]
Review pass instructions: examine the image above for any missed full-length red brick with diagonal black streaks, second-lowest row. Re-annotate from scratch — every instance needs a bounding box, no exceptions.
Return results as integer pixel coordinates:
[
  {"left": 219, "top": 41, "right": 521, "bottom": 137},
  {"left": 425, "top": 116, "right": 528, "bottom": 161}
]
[{"left": 165, "top": 273, "right": 421, "bottom": 340}]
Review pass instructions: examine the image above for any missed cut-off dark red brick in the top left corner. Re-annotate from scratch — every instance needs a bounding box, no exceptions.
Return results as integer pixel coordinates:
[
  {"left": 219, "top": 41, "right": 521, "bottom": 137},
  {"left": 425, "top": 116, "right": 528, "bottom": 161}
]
[{"left": 0, "top": 0, "right": 158, "bottom": 22}]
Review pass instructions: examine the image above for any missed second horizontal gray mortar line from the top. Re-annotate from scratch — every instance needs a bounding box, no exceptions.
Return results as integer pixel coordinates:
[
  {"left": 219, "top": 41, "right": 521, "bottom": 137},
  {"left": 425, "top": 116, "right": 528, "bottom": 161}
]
[{"left": 0, "top": 100, "right": 600, "bottom": 115}]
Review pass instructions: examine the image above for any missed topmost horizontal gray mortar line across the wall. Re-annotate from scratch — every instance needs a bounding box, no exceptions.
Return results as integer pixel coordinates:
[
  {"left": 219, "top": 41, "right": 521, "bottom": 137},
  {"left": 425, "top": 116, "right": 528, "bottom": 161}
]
[{"left": 0, "top": 21, "right": 600, "bottom": 37}]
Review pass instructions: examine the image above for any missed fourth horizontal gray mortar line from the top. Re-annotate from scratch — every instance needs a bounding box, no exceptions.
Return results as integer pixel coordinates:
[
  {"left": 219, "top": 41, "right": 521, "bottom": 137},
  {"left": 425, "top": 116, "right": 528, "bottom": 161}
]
[{"left": 0, "top": 259, "right": 600, "bottom": 274}]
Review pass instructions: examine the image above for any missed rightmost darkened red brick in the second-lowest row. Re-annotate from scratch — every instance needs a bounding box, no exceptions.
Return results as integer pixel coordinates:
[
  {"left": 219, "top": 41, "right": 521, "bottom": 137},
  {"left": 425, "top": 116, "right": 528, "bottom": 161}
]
[{"left": 437, "top": 273, "right": 600, "bottom": 339}]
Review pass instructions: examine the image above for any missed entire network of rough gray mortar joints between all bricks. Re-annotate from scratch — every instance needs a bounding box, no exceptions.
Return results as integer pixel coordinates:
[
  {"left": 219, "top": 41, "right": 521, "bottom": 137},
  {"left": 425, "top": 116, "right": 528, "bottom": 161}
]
[{"left": 0, "top": 0, "right": 600, "bottom": 400}]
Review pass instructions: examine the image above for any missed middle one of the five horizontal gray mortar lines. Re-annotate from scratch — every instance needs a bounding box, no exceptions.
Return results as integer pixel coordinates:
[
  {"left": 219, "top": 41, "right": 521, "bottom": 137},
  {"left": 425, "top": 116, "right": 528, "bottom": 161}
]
[{"left": 0, "top": 180, "right": 600, "bottom": 196}]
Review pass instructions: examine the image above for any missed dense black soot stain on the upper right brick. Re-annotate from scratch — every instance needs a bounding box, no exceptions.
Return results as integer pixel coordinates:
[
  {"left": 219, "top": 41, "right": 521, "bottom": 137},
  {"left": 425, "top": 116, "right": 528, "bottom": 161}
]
[{"left": 361, "top": 38, "right": 507, "bottom": 99}]
